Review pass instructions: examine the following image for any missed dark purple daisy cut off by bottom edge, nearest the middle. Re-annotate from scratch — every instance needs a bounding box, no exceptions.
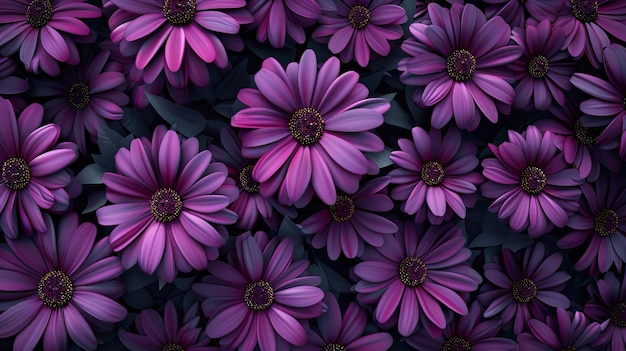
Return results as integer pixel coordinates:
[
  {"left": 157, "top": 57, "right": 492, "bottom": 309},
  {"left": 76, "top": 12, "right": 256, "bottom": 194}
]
[{"left": 294, "top": 292, "right": 393, "bottom": 351}]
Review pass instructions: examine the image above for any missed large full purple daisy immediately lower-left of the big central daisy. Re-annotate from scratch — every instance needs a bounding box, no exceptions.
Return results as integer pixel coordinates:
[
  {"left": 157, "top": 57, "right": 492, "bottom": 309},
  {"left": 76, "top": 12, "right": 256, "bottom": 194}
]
[{"left": 96, "top": 126, "right": 239, "bottom": 282}]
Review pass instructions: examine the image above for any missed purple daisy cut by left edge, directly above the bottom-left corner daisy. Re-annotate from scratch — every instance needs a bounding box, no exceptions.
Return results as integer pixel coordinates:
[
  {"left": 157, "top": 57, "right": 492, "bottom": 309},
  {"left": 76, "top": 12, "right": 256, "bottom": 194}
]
[{"left": 0, "top": 99, "right": 78, "bottom": 239}]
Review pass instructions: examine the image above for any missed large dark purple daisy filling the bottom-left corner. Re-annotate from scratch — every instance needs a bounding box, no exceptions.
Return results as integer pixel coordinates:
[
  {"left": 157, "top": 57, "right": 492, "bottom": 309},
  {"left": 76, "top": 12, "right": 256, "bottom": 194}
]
[{"left": 0, "top": 213, "right": 126, "bottom": 350}]
